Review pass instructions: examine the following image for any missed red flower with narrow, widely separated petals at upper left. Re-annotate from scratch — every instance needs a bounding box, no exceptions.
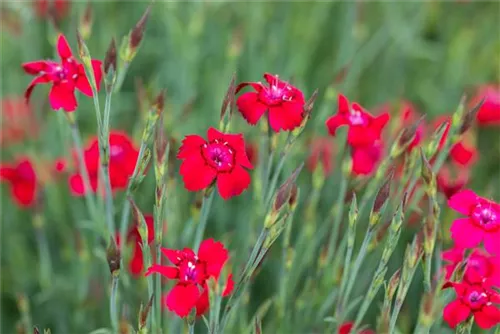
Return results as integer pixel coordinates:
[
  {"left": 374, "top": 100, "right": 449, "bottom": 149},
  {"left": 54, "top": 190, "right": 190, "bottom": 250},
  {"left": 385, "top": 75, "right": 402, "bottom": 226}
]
[{"left": 23, "top": 35, "right": 102, "bottom": 112}]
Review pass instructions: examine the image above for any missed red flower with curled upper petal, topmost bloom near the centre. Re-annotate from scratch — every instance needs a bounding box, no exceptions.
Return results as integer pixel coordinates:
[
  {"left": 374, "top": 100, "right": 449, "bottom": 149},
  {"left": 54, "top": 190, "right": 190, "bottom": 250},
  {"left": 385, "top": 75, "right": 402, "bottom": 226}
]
[{"left": 236, "top": 73, "right": 305, "bottom": 132}]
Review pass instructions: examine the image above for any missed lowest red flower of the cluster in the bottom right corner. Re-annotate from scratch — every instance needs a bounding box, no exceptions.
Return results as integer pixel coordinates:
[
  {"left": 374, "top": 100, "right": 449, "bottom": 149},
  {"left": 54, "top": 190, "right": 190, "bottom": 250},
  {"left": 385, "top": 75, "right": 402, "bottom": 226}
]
[{"left": 443, "top": 277, "right": 500, "bottom": 329}]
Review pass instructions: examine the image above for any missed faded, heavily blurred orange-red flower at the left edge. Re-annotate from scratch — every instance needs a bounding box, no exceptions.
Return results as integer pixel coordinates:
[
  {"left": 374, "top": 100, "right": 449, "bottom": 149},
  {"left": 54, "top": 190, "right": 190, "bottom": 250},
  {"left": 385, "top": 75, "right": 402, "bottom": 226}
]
[{"left": 0, "top": 97, "right": 38, "bottom": 147}]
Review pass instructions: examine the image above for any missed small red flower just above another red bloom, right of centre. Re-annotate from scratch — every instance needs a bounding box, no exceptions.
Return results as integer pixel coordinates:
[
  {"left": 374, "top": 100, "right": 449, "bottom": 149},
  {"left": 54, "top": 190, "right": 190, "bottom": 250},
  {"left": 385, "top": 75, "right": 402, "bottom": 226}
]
[{"left": 326, "top": 94, "right": 389, "bottom": 147}]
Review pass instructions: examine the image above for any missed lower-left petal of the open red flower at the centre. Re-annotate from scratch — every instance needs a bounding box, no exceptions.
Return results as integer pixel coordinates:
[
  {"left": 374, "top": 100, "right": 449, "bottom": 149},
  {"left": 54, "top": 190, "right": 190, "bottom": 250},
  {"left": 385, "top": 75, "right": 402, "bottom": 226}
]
[{"left": 180, "top": 151, "right": 217, "bottom": 191}]
